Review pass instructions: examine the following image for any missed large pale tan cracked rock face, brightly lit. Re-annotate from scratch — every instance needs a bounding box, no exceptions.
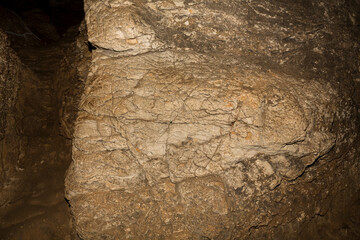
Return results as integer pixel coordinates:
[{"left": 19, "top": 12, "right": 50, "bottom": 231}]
[{"left": 66, "top": 0, "right": 360, "bottom": 239}]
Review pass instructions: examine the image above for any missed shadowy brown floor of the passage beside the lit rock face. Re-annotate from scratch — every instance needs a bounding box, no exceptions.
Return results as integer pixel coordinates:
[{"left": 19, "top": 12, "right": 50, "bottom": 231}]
[{"left": 0, "top": 42, "right": 73, "bottom": 240}]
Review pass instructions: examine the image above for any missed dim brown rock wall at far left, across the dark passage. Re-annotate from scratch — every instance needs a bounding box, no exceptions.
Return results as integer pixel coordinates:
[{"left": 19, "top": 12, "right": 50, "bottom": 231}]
[{"left": 0, "top": 30, "right": 36, "bottom": 206}]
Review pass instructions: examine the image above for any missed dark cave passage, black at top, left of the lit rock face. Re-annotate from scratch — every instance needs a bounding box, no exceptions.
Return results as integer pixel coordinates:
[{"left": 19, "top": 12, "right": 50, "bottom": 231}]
[{"left": 0, "top": 0, "right": 87, "bottom": 239}]
